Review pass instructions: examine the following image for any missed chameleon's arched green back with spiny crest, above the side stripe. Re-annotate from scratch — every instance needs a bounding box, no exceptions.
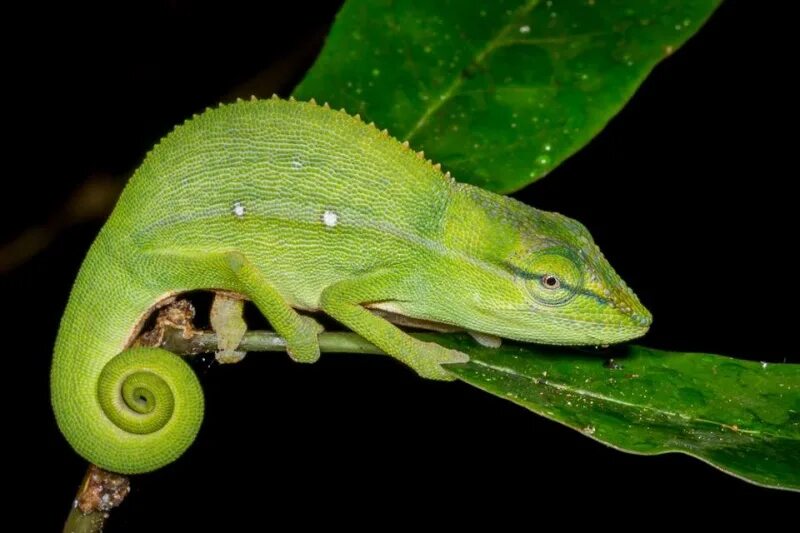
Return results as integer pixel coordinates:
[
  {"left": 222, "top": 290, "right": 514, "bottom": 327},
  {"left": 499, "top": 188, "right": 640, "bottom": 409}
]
[{"left": 120, "top": 99, "right": 451, "bottom": 244}]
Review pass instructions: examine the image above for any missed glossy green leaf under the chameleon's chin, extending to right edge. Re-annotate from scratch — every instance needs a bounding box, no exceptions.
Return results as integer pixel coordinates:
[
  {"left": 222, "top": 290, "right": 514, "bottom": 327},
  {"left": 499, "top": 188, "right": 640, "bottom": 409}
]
[{"left": 438, "top": 335, "right": 800, "bottom": 491}]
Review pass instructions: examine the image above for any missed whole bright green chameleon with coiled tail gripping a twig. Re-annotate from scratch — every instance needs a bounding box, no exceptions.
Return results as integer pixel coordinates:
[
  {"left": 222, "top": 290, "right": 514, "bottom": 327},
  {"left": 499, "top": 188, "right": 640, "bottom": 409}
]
[{"left": 50, "top": 97, "right": 652, "bottom": 474}]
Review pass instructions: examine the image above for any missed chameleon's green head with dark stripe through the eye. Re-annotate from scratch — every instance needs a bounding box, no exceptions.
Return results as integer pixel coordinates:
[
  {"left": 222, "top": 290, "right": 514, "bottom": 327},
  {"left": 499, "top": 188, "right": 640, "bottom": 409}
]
[{"left": 446, "top": 187, "right": 652, "bottom": 345}]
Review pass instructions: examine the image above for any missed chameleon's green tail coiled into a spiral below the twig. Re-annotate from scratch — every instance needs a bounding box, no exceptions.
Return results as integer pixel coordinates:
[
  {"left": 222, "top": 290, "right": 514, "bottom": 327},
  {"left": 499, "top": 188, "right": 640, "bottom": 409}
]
[{"left": 50, "top": 234, "right": 204, "bottom": 474}]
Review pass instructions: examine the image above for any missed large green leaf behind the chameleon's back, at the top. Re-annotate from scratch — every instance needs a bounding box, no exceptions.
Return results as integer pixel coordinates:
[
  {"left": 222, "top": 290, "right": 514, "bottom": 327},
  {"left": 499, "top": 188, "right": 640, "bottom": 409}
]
[{"left": 295, "top": 0, "right": 720, "bottom": 192}]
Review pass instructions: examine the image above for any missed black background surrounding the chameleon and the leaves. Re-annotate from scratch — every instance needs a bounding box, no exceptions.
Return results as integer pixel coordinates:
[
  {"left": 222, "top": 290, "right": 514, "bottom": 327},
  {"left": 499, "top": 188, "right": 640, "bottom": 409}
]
[{"left": 7, "top": 1, "right": 800, "bottom": 532}]
